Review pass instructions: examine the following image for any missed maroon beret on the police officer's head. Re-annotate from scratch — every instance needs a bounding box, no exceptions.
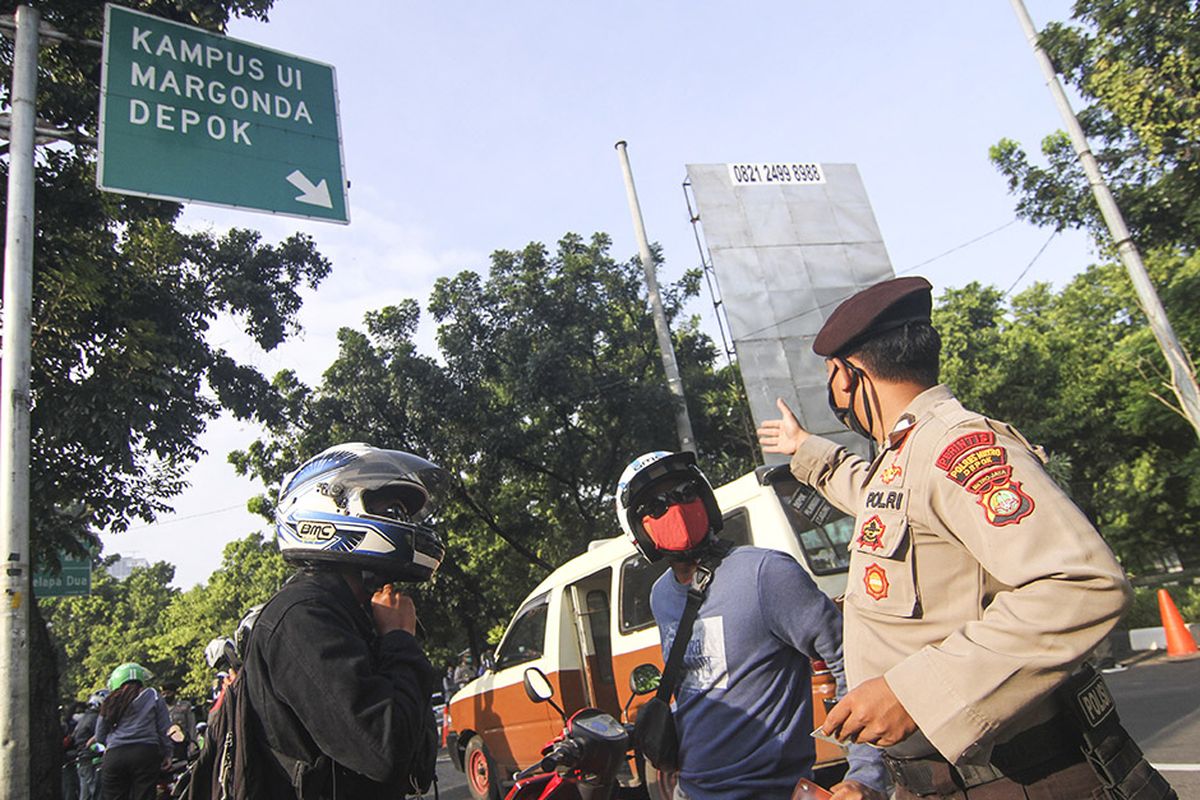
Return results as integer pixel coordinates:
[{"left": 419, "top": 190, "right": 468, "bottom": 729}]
[{"left": 812, "top": 276, "right": 934, "bottom": 359}]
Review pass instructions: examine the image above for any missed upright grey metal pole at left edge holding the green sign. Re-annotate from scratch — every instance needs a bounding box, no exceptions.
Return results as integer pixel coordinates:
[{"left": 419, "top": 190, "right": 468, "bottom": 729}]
[{"left": 0, "top": 6, "right": 41, "bottom": 800}]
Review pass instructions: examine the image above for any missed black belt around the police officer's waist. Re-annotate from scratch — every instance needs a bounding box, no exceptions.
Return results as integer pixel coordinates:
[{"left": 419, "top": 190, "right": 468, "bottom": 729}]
[{"left": 883, "top": 714, "right": 1085, "bottom": 795}]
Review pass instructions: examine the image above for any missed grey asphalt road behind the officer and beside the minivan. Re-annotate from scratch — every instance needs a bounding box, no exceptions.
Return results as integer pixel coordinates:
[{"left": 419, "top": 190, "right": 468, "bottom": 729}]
[{"left": 438, "top": 656, "right": 1200, "bottom": 800}]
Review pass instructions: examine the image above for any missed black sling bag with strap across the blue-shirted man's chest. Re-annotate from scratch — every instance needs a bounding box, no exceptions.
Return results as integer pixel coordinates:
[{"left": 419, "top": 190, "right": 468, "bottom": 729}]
[{"left": 634, "top": 559, "right": 720, "bottom": 772}]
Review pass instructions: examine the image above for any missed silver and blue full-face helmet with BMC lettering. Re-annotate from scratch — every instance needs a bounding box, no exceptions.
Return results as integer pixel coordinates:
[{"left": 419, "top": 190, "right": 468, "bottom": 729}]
[{"left": 275, "top": 443, "right": 445, "bottom": 581}]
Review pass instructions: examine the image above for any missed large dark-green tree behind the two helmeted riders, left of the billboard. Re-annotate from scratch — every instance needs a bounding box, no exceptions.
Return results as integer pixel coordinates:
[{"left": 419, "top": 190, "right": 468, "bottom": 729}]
[{"left": 234, "top": 234, "right": 755, "bottom": 662}]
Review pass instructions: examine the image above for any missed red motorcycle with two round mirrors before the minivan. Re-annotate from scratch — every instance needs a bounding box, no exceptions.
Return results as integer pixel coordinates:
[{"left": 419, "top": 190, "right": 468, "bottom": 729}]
[{"left": 505, "top": 664, "right": 659, "bottom": 800}]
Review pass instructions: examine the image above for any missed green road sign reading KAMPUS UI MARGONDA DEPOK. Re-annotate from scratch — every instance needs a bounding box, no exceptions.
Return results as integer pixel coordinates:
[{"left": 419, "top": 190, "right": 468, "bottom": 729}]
[{"left": 96, "top": 5, "right": 349, "bottom": 222}]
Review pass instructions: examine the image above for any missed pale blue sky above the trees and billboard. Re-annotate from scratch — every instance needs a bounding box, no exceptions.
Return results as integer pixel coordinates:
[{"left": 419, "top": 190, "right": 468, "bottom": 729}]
[{"left": 106, "top": 0, "right": 1093, "bottom": 588}]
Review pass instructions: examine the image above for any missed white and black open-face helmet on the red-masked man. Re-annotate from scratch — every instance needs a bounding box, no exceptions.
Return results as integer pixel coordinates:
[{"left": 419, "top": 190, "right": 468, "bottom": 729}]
[{"left": 617, "top": 450, "right": 724, "bottom": 561}]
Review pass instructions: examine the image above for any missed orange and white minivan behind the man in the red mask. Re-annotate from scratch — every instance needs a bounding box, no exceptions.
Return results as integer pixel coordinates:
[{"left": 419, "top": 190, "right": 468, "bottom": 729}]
[{"left": 448, "top": 465, "right": 853, "bottom": 800}]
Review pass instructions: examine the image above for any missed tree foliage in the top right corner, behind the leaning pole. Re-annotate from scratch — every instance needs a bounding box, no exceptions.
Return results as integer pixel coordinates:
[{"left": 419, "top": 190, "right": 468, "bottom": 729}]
[{"left": 992, "top": 0, "right": 1200, "bottom": 252}]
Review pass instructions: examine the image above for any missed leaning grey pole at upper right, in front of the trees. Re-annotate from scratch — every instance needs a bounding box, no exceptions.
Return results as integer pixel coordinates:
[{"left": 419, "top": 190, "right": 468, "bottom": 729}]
[{"left": 1012, "top": 0, "right": 1200, "bottom": 437}]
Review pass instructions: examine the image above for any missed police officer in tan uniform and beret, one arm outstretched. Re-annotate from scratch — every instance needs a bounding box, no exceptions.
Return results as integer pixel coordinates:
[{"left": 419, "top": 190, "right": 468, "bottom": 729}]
[{"left": 758, "top": 277, "right": 1174, "bottom": 799}]
